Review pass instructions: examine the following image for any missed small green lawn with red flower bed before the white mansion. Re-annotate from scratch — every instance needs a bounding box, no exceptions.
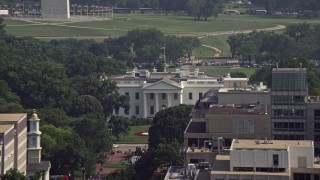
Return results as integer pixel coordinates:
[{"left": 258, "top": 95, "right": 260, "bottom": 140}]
[{"left": 116, "top": 125, "right": 150, "bottom": 143}]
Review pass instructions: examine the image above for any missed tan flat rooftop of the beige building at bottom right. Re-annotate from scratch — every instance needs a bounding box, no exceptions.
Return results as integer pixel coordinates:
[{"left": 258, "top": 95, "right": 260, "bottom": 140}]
[{"left": 230, "top": 139, "right": 313, "bottom": 150}]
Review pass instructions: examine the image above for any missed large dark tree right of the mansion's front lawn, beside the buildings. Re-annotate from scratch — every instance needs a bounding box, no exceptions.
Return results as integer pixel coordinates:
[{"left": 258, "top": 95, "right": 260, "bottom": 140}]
[{"left": 149, "top": 105, "right": 192, "bottom": 148}]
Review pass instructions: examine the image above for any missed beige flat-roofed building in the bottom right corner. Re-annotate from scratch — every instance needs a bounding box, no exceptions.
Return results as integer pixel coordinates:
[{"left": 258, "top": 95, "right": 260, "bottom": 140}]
[{"left": 210, "top": 139, "right": 320, "bottom": 180}]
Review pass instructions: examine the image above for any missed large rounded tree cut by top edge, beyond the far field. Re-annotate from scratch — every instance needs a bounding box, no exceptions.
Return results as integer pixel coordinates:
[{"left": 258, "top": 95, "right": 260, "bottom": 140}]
[{"left": 186, "top": 0, "right": 223, "bottom": 21}]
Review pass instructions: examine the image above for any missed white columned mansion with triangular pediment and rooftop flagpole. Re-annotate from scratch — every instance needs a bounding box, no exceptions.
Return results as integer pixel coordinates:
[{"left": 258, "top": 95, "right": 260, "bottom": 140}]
[{"left": 111, "top": 68, "right": 224, "bottom": 118}]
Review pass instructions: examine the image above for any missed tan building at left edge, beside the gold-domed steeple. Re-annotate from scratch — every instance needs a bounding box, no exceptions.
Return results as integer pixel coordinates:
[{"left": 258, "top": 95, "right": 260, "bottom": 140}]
[{"left": 0, "top": 114, "right": 27, "bottom": 174}]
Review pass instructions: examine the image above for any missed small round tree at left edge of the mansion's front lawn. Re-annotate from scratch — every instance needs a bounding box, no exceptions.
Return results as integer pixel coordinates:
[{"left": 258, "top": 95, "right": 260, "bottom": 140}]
[{"left": 109, "top": 116, "right": 130, "bottom": 141}]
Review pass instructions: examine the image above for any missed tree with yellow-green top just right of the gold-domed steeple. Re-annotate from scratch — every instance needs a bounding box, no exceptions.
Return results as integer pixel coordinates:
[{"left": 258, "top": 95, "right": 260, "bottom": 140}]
[{"left": 41, "top": 125, "right": 97, "bottom": 177}]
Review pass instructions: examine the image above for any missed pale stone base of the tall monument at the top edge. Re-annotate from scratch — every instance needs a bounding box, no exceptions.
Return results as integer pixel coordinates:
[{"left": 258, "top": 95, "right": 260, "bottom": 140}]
[{"left": 41, "top": 0, "right": 70, "bottom": 19}]
